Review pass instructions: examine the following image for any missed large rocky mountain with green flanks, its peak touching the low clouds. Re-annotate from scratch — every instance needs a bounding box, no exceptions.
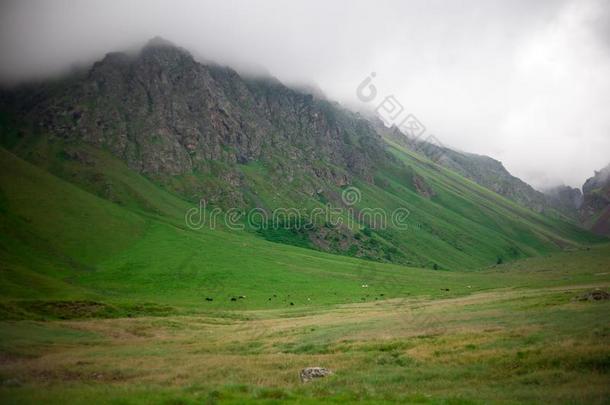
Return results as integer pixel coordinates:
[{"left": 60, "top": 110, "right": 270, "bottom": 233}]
[{"left": 0, "top": 38, "right": 597, "bottom": 269}]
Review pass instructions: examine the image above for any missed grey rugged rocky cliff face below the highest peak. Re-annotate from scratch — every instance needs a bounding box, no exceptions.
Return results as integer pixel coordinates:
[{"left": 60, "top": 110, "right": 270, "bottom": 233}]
[{"left": 3, "top": 38, "right": 384, "bottom": 205}]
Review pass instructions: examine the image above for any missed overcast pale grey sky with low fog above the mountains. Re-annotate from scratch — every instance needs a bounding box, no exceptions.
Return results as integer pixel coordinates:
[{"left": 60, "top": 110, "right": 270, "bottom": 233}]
[{"left": 0, "top": 0, "right": 610, "bottom": 188}]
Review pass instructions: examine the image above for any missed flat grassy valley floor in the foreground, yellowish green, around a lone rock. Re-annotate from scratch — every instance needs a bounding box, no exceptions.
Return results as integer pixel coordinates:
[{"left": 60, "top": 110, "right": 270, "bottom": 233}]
[{"left": 0, "top": 245, "right": 610, "bottom": 404}]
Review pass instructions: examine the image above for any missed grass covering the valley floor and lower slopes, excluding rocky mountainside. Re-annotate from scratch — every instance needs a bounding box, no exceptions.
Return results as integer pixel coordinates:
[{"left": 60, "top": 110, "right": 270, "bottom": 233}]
[{"left": 0, "top": 137, "right": 610, "bottom": 404}]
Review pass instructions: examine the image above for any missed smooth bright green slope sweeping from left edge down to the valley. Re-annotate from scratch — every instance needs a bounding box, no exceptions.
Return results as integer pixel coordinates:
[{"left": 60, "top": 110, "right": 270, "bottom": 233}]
[{"left": 0, "top": 145, "right": 490, "bottom": 309}]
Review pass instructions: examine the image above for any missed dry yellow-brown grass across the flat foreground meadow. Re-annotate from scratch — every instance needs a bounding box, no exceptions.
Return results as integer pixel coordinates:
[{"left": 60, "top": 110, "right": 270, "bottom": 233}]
[{"left": 0, "top": 288, "right": 610, "bottom": 403}]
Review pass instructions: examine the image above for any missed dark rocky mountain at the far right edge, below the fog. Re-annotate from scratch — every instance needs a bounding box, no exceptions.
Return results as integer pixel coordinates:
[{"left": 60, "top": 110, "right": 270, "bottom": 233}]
[{"left": 580, "top": 164, "right": 610, "bottom": 236}]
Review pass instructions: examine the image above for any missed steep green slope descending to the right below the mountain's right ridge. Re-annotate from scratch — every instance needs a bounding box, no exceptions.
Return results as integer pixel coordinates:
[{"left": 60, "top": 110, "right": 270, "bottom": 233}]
[{"left": 328, "top": 139, "right": 599, "bottom": 269}]
